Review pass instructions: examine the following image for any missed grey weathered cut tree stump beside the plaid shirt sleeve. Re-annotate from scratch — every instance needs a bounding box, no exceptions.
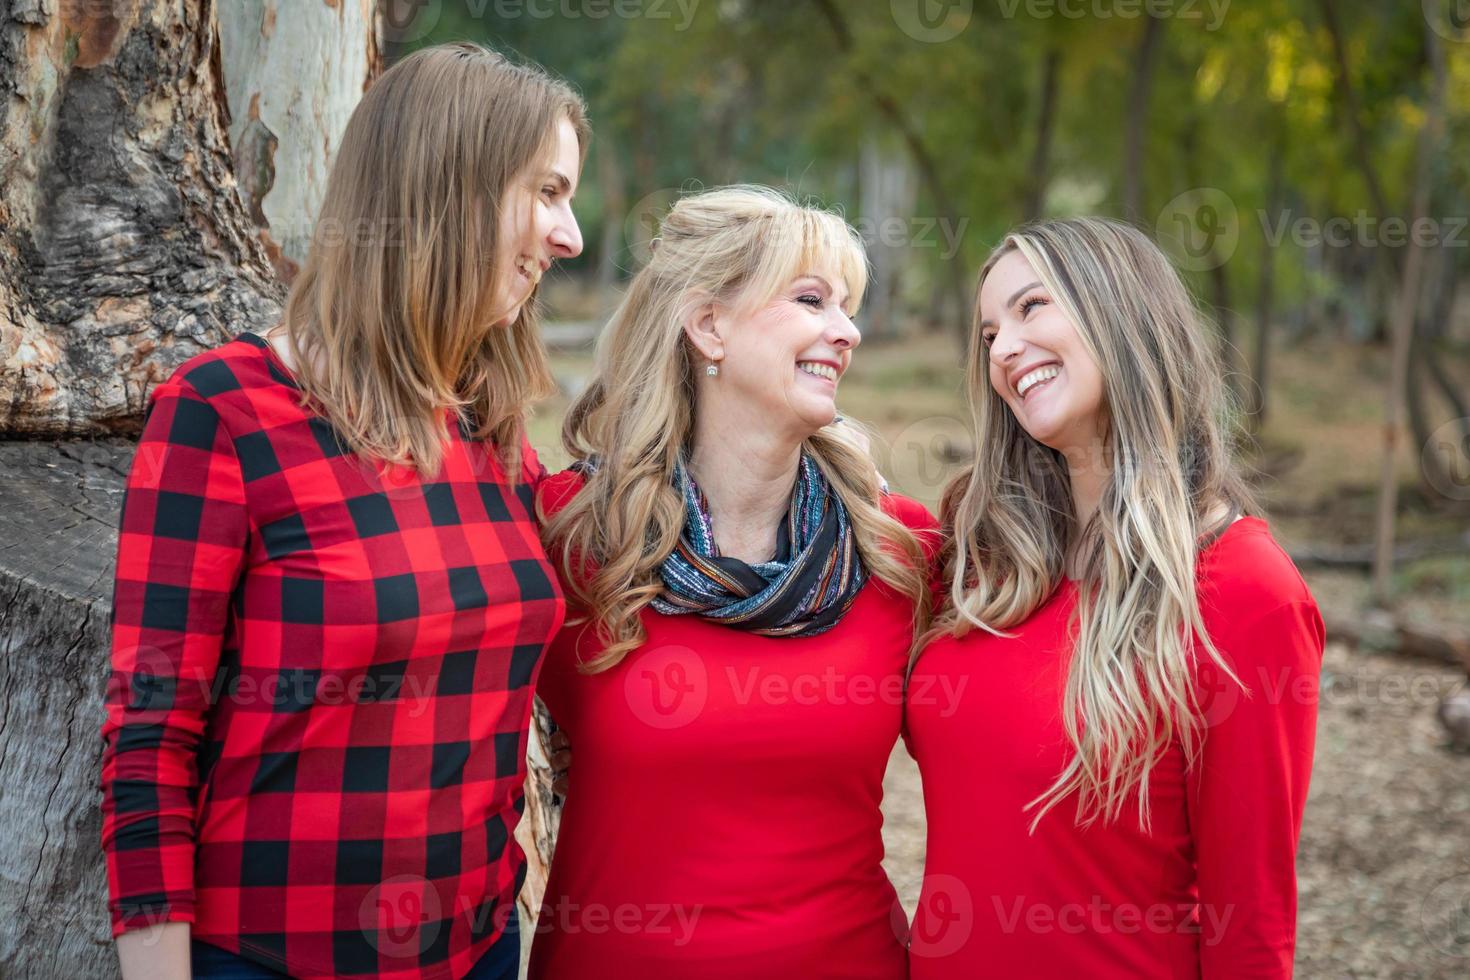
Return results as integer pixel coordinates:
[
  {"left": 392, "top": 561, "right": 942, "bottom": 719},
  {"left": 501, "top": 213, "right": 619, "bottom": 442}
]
[{"left": 0, "top": 441, "right": 134, "bottom": 977}]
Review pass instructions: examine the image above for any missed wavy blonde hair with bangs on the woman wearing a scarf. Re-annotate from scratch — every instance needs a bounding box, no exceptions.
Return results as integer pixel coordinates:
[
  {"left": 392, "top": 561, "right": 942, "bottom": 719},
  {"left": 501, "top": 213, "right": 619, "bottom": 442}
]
[{"left": 544, "top": 185, "right": 928, "bottom": 673}]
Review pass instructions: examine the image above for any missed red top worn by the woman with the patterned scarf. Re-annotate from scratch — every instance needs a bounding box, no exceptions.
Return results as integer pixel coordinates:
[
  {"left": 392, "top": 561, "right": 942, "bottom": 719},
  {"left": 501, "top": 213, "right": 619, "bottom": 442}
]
[{"left": 529, "top": 472, "right": 933, "bottom": 980}]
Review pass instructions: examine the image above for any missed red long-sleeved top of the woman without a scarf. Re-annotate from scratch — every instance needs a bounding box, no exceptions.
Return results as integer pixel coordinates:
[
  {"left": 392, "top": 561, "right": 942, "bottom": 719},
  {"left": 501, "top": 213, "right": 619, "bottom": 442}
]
[{"left": 907, "top": 517, "right": 1323, "bottom": 980}]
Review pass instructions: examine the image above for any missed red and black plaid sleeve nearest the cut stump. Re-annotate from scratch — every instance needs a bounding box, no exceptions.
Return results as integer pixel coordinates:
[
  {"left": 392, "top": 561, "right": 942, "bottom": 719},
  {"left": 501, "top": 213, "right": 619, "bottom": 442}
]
[{"left": 101, "top": 379, "right": 248, "bottom": 936}]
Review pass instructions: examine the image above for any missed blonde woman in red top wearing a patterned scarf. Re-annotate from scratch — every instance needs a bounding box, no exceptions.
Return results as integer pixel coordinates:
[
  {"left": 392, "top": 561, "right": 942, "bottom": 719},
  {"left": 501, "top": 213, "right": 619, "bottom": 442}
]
[{"left": 531, "top": 187, "right": 936, "bottom": 980}]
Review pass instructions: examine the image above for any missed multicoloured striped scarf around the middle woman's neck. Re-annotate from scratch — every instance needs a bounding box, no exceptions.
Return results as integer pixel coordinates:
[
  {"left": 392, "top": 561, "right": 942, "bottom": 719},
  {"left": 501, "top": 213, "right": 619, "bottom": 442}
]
[{"left": 653, "top": 453, "right": 867, "bottom": 636}]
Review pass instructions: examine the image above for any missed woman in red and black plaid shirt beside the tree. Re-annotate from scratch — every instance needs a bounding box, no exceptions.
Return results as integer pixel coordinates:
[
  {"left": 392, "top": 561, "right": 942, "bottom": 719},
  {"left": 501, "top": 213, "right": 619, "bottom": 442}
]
[{"left": 101, "top": 44, "right": 588, "bottom": 980}]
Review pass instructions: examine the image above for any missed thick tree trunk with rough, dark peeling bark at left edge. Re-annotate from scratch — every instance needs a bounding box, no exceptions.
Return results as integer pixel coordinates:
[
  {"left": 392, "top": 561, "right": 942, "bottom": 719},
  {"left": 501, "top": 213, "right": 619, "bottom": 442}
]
[{"left": 0, "top": 0, "right": 281, "bottom": 436}]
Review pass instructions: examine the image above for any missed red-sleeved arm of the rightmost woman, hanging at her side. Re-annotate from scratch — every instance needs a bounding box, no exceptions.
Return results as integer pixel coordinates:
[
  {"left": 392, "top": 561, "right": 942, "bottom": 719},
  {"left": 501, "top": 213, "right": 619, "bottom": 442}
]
[{"left": 1188, "top": 599, "right": 1324, "bottom": 980}]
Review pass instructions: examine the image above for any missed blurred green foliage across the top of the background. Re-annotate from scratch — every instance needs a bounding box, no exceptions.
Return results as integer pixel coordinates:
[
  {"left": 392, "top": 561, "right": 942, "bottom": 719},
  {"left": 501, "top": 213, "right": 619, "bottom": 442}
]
[{"left": 402, "top": 0, "right": 1470, "bottom": 329}]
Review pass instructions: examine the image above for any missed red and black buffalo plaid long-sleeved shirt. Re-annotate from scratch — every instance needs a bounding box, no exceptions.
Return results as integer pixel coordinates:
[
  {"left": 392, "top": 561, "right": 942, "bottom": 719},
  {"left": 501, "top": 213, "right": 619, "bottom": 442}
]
[{"left": 101, "top": 334, "right": 564, "bottom": 980}]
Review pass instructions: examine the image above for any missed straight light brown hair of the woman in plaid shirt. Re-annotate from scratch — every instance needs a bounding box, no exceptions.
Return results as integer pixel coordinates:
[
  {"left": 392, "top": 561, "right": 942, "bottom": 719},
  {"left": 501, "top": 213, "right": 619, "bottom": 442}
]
[{"left": 282, "top": 43, "right": 589, "bottom": 480}]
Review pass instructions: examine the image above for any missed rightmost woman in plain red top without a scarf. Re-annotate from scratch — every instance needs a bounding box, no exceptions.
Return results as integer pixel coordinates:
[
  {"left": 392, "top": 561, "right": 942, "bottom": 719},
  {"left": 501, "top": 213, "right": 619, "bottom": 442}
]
[{"left": 908, "top": 217, "right": 1323, "bottom": 980}]
